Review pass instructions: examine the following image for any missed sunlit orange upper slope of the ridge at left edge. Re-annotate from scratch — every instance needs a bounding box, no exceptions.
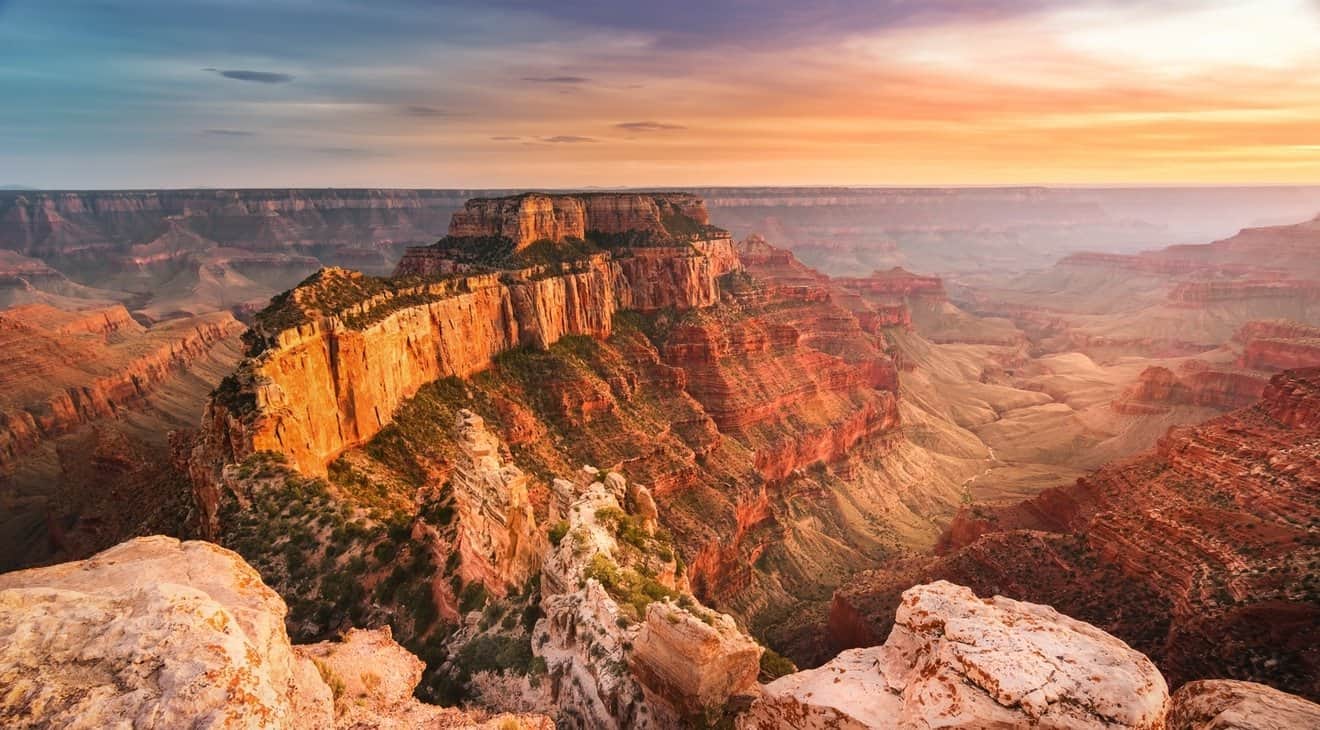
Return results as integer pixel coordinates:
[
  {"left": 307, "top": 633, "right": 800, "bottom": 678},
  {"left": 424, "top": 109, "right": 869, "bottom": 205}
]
[{"left": 0, "top": 304, "right": 243, "bottom": 470}]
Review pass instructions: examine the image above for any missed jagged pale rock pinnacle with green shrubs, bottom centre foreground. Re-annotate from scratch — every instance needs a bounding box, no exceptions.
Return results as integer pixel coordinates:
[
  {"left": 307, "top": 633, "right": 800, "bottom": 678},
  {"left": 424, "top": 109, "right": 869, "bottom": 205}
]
[{"left": 532, "top": 470, "right": 762, "bottom": 727}]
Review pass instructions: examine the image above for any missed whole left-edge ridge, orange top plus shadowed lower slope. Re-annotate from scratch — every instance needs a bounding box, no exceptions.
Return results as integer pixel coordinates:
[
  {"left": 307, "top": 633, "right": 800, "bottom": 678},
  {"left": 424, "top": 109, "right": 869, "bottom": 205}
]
[{"left": 0, "top": 304, "right": 243, "bottom": 570}]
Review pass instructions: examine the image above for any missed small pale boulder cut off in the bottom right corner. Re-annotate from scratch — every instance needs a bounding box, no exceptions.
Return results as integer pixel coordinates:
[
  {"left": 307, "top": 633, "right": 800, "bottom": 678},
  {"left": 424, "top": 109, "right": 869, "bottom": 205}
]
[{"left": 1166, "top": 680, "right": 1320, "bottom": 730}]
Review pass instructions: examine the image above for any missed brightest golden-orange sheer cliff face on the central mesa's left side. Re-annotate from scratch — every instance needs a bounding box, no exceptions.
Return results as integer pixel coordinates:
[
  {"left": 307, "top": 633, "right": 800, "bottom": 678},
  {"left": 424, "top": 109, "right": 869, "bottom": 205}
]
[{"left": 198, "top": 262, "right": 615, "bottom": 483}]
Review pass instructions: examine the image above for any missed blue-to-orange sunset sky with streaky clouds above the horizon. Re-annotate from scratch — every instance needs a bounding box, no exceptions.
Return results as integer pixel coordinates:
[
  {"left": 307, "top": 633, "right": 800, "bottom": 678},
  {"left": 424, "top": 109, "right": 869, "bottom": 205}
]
[{"left": 0, "top": 0, "right": 1320, "bottom": 187}]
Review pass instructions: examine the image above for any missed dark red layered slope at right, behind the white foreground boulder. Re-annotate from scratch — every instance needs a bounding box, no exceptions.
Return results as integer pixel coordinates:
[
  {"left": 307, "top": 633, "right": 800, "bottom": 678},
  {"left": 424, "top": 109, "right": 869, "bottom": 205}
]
[{"left": 832, "top": 368, "right": 1320, "bottom": 698}]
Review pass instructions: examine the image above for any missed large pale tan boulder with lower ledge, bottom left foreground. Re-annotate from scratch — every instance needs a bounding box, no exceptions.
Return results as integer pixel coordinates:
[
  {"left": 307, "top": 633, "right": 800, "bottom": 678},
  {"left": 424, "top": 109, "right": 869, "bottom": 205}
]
[{"left": 0, "top": 537, "right": 550, "bottom": 729}]
